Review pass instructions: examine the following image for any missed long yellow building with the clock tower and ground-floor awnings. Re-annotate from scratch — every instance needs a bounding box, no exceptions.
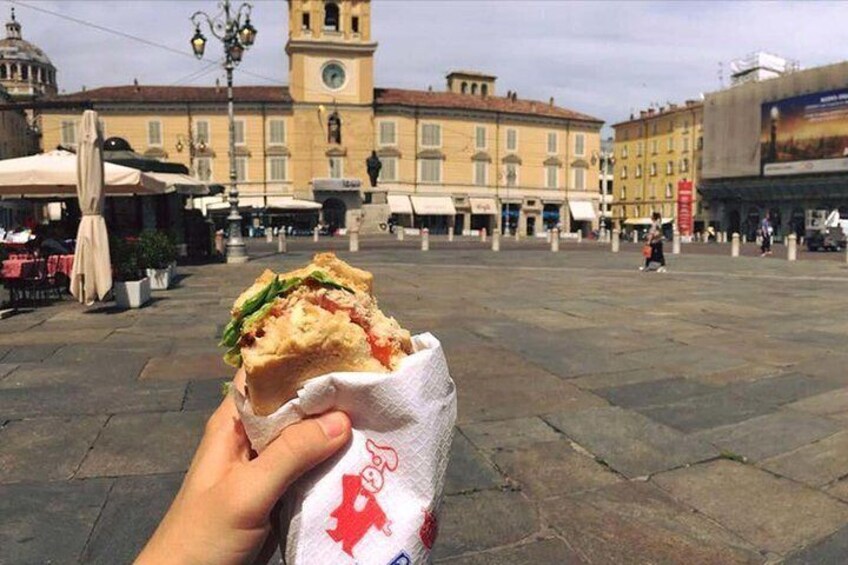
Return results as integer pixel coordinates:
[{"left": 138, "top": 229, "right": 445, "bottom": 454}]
[{"left": 42, "top": 0, "right": 602, "bottom": 234}]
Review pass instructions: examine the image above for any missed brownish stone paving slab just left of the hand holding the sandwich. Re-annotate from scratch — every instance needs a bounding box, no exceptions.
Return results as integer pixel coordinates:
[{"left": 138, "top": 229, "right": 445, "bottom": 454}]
[{"left": 77, "top": 412, "right": 209, "bottom": 477}]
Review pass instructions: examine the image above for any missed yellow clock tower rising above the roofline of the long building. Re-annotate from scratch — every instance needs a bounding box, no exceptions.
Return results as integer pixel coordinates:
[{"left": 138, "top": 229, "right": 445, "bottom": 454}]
[{"left": 286, "top": 0, "right": 377, "bottom": 105}]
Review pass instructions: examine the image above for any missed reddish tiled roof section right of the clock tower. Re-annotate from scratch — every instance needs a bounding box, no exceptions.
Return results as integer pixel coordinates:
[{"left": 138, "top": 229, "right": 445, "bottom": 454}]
[{"left": 374, "top": 88, "right": 603, "bottom": 124}]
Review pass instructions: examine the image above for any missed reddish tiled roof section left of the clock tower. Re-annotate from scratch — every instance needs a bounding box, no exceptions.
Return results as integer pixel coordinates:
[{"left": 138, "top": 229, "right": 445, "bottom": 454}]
[{"left": 49, "top": 84, "right": 292, "bottom": 103}]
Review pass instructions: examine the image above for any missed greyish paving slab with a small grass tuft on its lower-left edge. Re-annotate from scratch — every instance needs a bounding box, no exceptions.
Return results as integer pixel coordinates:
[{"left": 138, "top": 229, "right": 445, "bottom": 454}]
[{"left": 544, "top": 407, "right": 718, "bottom": 478}]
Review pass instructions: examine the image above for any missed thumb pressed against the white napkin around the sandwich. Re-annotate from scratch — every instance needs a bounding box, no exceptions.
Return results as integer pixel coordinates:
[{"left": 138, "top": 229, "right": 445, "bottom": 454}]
[{"left": 237, "top": 412, "right": 350, "bottom": 511}]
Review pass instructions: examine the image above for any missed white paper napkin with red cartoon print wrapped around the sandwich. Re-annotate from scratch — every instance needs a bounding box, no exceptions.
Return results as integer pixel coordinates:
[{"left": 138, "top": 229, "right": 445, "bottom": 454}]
[{"left": 235, "top": 333, "right": 456, "bottom": 565}]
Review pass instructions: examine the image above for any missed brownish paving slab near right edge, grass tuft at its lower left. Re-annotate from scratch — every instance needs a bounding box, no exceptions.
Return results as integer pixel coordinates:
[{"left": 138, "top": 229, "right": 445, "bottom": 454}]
[{"left": 694, "top": 411, "right": 842, "bottom": 461}]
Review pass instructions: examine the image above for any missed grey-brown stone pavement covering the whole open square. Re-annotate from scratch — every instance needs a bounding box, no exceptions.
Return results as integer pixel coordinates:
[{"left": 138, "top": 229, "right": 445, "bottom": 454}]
[{"left": 0, "top": 238, "right": 848, "bottom": 565}]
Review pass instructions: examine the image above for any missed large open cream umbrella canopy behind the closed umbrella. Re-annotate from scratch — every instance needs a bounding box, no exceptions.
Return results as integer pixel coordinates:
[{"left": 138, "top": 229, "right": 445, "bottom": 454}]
[{"left": 0, "top": 145, "right": 167, "bottom": 198}]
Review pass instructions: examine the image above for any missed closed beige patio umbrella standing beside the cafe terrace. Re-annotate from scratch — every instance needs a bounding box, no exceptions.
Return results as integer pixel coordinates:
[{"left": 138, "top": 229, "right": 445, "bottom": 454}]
[{"left": 71, "top": 110, "right": 112, "bottom": 305}]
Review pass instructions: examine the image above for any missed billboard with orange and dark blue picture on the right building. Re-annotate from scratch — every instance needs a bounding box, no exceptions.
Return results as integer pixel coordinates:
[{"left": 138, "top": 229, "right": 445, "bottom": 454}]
[{"left": 760, "top": 88, "right": 848, "bottom": 176}]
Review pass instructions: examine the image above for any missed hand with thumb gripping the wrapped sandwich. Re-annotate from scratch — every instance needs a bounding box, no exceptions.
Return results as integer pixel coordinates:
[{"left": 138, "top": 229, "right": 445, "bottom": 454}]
[{"left": 136, "top": 371, "right": 350, "bottom": 565}]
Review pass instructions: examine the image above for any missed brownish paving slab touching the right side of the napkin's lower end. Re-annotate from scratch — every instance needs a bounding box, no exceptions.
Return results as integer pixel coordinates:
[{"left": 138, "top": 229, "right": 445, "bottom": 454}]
[{"left": 433, "top": 490, "right": 541, "bottom": 561}]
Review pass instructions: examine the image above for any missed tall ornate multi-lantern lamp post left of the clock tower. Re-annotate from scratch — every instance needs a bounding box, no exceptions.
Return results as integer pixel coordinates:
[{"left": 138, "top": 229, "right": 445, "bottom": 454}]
[{"left": 191, "top": 0, "right": 256, "bottom": 263}]
